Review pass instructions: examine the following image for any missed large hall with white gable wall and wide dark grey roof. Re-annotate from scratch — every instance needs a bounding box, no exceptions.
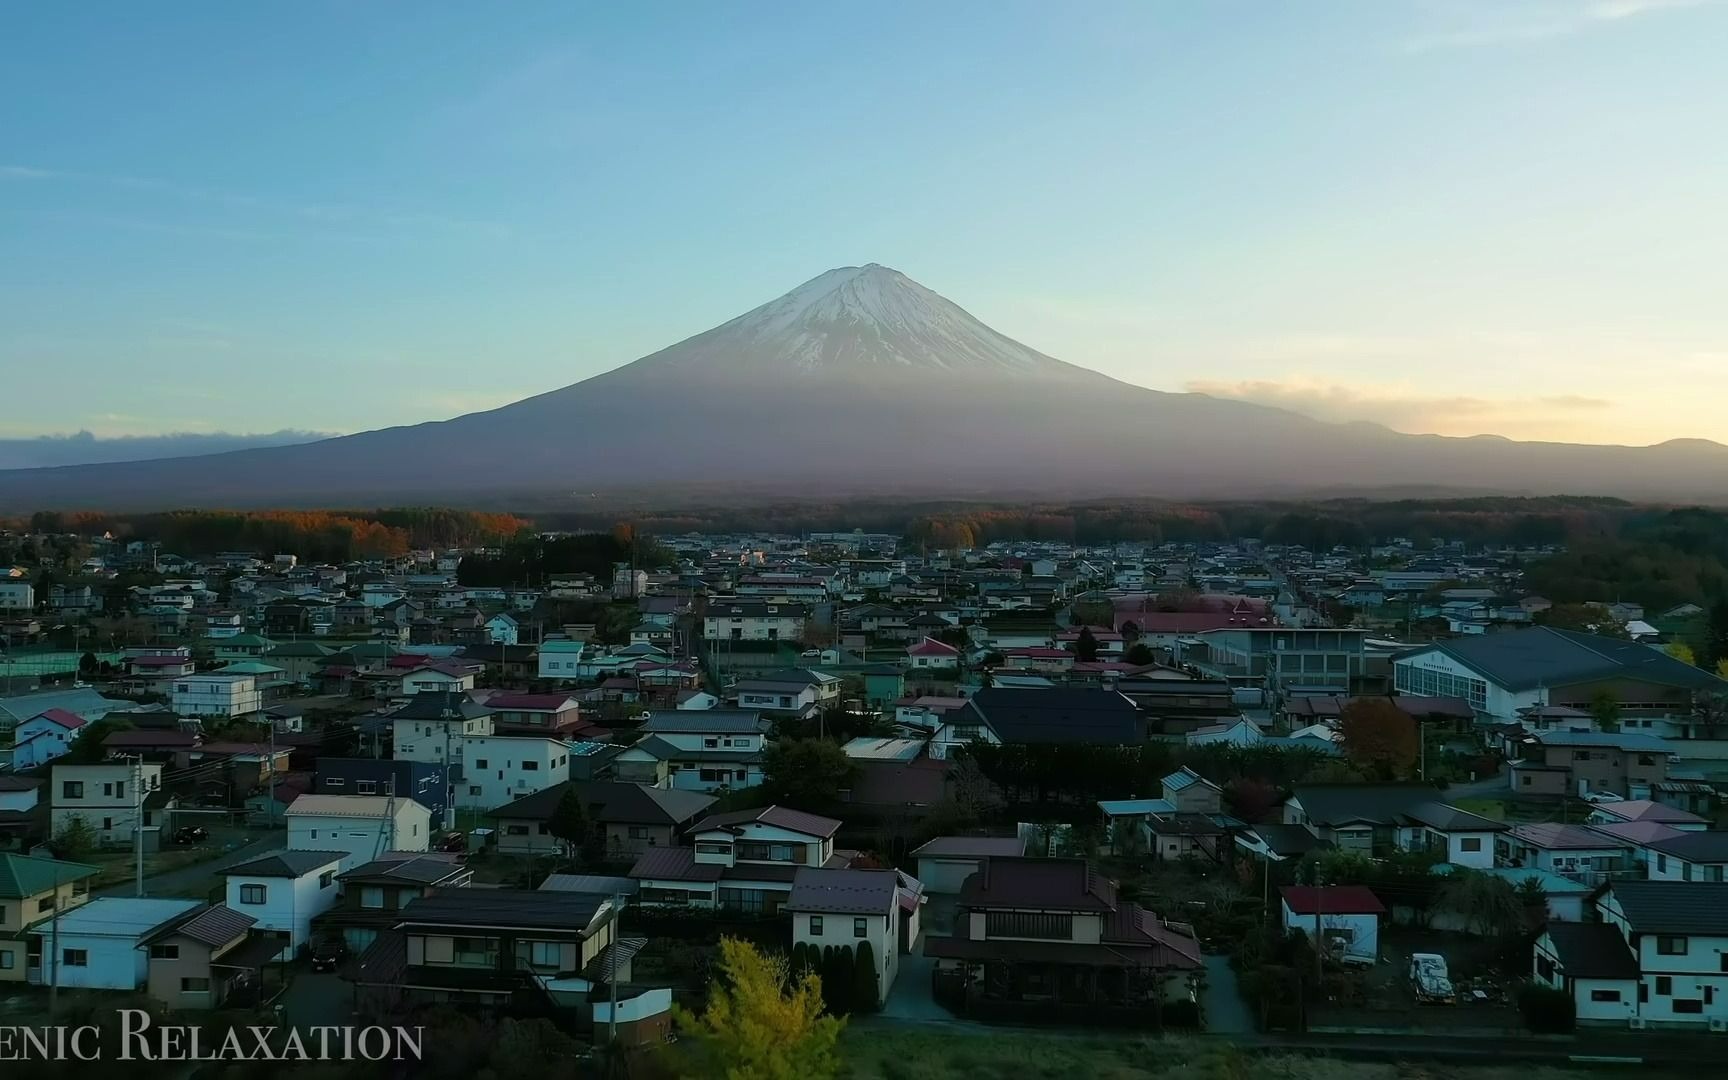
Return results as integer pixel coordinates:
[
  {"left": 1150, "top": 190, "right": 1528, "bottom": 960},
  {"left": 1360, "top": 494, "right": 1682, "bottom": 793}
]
[{"left": 1393, "top": 626, "right": 1728, "bottom": 738}]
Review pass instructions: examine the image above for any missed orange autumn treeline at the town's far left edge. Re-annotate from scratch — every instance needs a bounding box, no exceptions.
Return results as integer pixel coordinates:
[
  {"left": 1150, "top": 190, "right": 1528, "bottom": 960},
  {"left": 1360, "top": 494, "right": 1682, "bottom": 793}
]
[{"left": 18, "top": 506, "right": 532, "bottom": 562}]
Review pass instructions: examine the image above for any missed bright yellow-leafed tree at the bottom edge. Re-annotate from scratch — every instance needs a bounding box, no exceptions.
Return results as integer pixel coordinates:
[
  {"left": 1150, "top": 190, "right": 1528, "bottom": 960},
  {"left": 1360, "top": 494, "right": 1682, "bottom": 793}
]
[{"left": 672, "top": 938, "right": 845, "bottom": 1080}]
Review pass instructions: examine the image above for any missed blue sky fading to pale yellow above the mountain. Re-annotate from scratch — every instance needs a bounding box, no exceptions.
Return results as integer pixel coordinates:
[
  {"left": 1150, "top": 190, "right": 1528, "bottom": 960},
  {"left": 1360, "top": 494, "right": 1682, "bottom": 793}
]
[{"left": 0, "top": 0, "right": 1728, "bottom": 442}]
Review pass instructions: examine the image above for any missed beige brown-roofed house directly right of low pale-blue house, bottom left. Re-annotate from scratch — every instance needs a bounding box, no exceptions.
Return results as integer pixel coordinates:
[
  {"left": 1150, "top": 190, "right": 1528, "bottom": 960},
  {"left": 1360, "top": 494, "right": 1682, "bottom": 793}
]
[{"left": 138, "top": 904, "right": 282, "bottom": 1013}]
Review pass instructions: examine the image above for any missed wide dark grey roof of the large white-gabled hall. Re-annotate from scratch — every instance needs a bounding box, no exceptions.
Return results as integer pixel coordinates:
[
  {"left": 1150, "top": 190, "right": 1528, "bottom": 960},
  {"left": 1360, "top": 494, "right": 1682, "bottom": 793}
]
[{"left": 1405, "top": 626, "right": 1728, "bottom": 691}]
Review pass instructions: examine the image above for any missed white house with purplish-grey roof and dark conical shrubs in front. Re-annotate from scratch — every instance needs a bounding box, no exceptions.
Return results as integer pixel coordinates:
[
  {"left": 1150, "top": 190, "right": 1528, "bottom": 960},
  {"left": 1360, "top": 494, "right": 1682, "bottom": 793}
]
[{"left": 785, "top": 866, "right": 918, "bottom": 1004}]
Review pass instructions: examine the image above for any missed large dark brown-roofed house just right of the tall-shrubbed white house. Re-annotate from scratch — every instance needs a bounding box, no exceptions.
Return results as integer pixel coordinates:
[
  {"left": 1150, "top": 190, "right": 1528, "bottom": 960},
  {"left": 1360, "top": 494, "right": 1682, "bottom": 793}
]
[{"left": 924, "top": 857, "right": 1203, "bottom": 1023}]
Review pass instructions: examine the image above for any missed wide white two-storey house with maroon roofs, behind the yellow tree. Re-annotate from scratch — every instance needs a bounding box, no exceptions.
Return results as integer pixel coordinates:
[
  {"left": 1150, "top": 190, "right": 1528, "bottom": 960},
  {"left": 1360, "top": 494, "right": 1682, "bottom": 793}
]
[{"left": 631, "top": 807, "right": 847, "bottom": 914}]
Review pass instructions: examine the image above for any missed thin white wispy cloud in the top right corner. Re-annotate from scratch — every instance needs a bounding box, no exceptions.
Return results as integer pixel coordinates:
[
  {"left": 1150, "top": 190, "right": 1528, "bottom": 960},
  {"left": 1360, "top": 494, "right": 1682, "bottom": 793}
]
[{"left": 1400, "top": 0, "right": 1723, "bottom": 52}]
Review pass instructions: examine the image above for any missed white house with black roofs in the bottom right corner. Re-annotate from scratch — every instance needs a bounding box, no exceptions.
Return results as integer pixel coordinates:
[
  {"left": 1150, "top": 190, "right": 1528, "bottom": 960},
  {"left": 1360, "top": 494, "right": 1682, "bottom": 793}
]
[{"left": 1533, "top": 881, "right": 1728, "bottom": 1030}]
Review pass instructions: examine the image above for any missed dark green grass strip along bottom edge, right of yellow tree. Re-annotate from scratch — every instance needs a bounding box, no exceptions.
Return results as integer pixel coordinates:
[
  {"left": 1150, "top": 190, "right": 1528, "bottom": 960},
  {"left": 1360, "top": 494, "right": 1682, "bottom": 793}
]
[{"left": 840, "top": 1026, "right": 1585, "bottom": 1080}]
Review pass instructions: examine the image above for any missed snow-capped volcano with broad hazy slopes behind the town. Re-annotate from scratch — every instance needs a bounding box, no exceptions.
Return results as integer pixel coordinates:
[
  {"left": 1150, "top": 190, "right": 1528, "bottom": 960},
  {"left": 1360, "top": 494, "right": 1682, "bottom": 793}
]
[{"left": 0, "top": 263, "right": 1728, "bottom": 511}]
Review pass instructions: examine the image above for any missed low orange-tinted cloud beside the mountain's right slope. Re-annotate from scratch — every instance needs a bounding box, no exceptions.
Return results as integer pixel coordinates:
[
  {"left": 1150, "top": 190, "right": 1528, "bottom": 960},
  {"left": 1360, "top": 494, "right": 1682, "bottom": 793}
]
[{"left": 1184, "top": 378, "right": 1614, "bottom": 435}]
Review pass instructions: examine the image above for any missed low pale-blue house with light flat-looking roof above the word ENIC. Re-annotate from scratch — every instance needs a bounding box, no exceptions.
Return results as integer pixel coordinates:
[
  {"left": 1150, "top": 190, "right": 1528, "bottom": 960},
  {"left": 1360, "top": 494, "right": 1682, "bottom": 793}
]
[{"left": 35, "top": 897, "right": 204, "bottom": 990}]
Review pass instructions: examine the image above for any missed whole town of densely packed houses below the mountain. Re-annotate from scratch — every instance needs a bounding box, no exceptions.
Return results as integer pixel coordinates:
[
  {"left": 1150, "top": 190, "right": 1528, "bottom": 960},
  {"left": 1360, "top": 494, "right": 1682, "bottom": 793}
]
[{"left": 0, "top": 532, "right": 1728, "bottom": 1045}]
